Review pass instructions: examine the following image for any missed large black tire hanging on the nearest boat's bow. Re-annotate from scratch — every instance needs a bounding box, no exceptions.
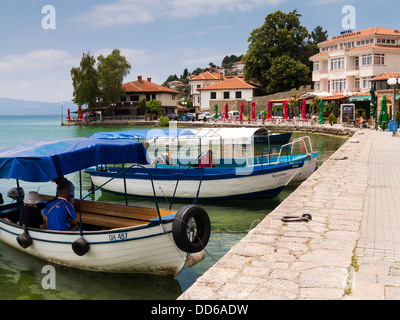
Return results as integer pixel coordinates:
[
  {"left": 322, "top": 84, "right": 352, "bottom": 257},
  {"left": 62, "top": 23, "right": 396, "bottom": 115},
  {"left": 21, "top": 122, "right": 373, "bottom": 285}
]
[{"left": 172, "top": 205, "right": 211, "bottom": 253}]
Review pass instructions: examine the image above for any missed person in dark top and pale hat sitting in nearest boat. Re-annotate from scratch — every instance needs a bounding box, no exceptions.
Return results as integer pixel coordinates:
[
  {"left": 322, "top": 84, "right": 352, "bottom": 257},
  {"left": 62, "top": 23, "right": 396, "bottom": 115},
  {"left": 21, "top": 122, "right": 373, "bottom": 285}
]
[{"left": 18, "top": 191, "right": 45, "bottom": 229}]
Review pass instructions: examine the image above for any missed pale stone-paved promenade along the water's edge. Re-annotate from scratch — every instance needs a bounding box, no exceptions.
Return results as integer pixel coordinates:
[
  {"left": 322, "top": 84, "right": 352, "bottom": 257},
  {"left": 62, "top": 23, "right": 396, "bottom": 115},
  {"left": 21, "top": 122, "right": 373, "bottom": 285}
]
[{"left": 179, "top": 129, "right": 400, "bottom": 300}]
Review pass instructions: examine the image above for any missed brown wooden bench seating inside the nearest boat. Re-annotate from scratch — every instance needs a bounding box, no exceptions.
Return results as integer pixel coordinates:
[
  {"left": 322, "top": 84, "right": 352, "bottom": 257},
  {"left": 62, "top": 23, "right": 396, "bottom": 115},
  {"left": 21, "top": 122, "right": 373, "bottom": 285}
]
[{"left": 41, "top": 195, "right": 176, "bottom": 229}]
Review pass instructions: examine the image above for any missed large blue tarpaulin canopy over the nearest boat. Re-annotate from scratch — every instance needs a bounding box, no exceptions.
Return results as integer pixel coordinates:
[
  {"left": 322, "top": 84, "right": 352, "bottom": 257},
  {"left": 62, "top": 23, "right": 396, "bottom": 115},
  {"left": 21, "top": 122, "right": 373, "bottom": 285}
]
[{"left": 0, "top": 138, "right": 149, "bottom": 182}]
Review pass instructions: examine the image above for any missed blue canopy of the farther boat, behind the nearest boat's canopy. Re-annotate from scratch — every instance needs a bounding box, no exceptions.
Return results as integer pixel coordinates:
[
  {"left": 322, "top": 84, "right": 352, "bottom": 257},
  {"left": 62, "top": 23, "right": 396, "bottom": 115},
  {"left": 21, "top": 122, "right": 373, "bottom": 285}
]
[{"left": 89, "top": 129, "right": 194, "bottom": 140}]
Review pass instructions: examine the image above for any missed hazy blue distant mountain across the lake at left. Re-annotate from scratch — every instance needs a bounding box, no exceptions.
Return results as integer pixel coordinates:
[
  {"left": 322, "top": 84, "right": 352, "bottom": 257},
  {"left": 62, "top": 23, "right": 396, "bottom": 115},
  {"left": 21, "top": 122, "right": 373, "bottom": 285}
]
[{"left": 0, "top": 98, "right": 78, "bottom": 115}]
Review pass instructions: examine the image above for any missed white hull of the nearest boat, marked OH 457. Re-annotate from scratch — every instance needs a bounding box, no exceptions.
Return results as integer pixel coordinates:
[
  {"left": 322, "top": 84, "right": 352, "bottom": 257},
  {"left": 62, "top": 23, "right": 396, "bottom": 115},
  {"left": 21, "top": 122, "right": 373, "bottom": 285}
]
[{"left": 0, "top": 219, "right": 187, "bottom": 276}]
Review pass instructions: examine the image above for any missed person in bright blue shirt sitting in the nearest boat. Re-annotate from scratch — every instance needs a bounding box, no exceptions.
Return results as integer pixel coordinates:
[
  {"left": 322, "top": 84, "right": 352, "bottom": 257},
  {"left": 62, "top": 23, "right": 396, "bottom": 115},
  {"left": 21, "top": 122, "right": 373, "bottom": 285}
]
[{"left": 43, "top": 186, "right": 77, "bottom": 231}]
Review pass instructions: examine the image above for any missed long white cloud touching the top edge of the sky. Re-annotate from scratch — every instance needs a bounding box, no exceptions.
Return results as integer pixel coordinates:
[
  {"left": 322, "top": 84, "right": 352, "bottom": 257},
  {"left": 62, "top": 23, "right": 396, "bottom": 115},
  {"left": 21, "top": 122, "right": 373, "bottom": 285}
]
[{"left": 78, "top": 0, "right": 285, "bottom": 27}]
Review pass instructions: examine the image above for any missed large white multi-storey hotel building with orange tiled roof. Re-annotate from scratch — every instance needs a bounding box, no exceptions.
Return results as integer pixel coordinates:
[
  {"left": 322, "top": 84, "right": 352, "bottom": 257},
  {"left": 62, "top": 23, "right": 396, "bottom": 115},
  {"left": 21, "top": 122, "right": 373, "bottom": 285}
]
[{"left": 310, "top": 27, "right": 400, "bottom": 97}]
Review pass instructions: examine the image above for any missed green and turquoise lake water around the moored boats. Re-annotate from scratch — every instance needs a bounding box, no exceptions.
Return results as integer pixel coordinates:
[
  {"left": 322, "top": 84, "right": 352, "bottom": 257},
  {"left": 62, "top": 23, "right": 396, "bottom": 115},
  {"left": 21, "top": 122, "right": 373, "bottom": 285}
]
[{"left": 0, "top": 116, "right": 346, "bottom": 300}]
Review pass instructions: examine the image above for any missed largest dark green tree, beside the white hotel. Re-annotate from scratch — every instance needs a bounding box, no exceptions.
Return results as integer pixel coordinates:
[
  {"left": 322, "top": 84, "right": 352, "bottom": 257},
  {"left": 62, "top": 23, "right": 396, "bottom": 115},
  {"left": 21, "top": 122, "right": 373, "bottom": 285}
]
[{"left": 243, "top": 10, "right": 311, "bottom": 93}]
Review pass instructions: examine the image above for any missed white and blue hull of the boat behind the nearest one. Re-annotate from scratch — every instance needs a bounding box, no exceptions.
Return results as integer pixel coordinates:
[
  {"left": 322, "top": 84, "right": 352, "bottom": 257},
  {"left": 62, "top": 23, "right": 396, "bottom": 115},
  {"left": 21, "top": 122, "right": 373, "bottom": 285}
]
[{"left": 90, "top": 165, "right": 301, "bottom": 199}]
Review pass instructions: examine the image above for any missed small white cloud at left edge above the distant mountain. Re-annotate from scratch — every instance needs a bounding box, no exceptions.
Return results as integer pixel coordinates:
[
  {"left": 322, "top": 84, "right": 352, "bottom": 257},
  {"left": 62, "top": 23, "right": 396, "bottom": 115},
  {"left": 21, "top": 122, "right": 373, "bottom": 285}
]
[{"left": 0, "top": 49, "right": 69, "bottom": 72}]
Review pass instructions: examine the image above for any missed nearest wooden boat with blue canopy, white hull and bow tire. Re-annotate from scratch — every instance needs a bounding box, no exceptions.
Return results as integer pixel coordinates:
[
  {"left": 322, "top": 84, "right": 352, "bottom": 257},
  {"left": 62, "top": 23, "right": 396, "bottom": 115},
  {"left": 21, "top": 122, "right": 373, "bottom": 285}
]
[{"left": 0, "top": 138, "right": 211, "bottom": 276}]
